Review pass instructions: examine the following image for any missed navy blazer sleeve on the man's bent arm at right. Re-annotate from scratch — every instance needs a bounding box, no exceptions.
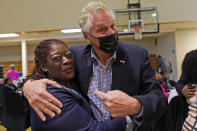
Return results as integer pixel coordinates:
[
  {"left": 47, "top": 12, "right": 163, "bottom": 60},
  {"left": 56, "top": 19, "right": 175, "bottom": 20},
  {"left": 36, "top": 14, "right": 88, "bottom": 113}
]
[{"left": 134, "top": 50, "right": 168, "bottom": 122}]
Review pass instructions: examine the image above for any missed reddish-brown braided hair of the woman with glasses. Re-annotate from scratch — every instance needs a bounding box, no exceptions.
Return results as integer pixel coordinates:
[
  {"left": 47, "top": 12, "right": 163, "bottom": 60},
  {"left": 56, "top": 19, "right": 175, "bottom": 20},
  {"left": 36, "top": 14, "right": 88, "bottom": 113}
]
[{"left": 27, "top": 39, "right": 67, "bottom": 80}]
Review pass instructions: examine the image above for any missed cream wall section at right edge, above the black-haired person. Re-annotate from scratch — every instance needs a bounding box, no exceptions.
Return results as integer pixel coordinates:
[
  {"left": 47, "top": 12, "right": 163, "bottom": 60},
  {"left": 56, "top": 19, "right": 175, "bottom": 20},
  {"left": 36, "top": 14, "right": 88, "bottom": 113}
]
[{"left": 175, "top": 29, "right": 197, "bottom": 77}]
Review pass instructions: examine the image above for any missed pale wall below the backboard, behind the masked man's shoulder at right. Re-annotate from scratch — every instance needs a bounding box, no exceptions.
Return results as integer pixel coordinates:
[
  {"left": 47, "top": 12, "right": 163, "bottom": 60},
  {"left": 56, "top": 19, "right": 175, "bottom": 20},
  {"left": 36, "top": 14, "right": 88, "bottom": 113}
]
[{"left": 123, "top": 33, "right": 177, "bottom": 81}]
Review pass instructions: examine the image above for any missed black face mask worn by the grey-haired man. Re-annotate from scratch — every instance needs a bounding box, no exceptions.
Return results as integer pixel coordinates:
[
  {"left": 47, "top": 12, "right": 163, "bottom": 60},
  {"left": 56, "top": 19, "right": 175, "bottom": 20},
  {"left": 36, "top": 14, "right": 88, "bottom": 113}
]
[{"left": 88, "top": 32, "right": 118, "bottom": 53}]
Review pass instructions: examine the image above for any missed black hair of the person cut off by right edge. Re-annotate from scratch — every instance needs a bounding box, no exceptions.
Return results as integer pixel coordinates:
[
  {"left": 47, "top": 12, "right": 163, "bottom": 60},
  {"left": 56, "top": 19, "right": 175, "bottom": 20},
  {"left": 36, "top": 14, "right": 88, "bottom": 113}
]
[{"left": 182, "top": 50, "right": 197, "bottom": 83}]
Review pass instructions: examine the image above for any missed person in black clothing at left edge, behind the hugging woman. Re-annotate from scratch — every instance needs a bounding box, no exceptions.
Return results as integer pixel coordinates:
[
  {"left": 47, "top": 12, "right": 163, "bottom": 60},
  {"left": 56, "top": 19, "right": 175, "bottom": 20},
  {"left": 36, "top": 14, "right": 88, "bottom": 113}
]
[{"left": 1, "top": 78, "right": 29, "bottom": 131}]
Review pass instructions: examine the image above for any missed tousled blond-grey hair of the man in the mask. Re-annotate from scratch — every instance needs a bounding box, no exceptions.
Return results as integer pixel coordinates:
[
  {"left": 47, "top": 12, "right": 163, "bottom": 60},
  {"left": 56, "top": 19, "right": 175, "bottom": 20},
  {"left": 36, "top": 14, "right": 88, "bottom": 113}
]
[{"left": 79, "top": 1, "right": 115, "bottom": 32}]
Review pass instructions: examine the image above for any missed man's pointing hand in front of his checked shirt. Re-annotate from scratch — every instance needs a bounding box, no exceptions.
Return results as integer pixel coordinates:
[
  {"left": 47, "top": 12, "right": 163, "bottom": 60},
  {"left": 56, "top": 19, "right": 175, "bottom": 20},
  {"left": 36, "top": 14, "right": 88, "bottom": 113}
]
[{"left": 94, "top": 90, "right": 142, "bottom": 118}]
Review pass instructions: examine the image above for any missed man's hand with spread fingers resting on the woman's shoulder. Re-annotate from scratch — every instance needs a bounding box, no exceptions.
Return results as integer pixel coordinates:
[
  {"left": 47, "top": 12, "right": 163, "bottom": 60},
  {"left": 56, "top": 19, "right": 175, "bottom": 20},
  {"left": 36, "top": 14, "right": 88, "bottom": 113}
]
[{"left": 23, "top": 79, "right": 62, "bottom": 121}]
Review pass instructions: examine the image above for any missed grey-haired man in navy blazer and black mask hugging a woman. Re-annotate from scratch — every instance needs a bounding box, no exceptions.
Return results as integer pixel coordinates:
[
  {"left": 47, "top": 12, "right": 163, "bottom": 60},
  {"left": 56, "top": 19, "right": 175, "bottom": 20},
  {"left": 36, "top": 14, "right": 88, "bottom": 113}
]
[{"left": 23, "top": 2, "right": 167, "bottom": 131}]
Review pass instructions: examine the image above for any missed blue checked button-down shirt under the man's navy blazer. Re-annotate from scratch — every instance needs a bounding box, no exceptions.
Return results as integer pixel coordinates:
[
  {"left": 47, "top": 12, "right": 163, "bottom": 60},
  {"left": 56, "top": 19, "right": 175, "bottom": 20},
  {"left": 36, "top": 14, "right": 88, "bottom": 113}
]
[{"left": 88, "top": 50, "right": 116, "bottom": 121}]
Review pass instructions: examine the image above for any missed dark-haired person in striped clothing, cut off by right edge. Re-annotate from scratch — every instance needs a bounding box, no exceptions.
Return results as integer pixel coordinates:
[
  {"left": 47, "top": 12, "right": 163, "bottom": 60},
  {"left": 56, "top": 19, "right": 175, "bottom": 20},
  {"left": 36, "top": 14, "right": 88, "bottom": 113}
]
[{"left": 174, "top": 50, "right": 197, "bottom": 131}]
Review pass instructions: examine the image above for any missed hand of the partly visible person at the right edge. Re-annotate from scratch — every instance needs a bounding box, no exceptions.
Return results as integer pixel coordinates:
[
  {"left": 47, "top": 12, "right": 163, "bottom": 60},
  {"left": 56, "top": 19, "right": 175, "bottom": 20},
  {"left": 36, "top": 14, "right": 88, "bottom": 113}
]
[{"left": 182, "top": 83, "right": 196, "bottom": 98}]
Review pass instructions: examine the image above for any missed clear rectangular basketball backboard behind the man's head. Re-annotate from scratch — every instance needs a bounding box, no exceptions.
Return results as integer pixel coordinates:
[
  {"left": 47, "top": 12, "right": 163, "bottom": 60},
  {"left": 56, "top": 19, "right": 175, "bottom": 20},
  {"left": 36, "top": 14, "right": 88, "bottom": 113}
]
[{"left": 114, "top": 7, "right": 159, "bottom": 35}]
